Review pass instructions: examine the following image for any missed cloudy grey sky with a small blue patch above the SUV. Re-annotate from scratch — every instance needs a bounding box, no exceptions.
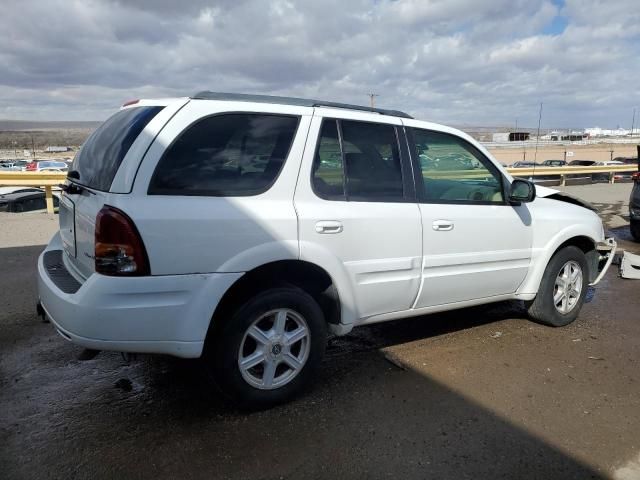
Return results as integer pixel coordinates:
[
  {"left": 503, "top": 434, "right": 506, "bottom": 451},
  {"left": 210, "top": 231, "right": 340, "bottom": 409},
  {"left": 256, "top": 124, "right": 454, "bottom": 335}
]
[{"left": 0, "top": 0, "right": 640, "bottom": 128}]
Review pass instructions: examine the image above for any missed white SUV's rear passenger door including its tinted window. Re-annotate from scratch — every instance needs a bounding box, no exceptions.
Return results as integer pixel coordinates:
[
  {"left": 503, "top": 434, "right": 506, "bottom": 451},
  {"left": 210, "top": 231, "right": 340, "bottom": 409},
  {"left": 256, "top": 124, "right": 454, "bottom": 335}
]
[{"left": 295, "top": 109, "right": 422, "bottom": 320}]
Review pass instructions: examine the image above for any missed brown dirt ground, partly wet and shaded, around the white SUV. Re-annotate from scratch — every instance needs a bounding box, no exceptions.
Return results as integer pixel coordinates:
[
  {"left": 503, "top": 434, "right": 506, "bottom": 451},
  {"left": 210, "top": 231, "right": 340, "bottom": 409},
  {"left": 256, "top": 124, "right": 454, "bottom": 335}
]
[{"left": 0, "top": 185, "right": 640, "bottom": 480}]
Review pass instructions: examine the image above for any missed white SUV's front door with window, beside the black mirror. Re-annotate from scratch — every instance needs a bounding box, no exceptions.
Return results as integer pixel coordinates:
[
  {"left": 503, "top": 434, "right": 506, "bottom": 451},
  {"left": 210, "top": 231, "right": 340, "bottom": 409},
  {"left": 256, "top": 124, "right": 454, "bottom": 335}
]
[{"left": 409, "top": 128, "right": 532, "bottom": 308}]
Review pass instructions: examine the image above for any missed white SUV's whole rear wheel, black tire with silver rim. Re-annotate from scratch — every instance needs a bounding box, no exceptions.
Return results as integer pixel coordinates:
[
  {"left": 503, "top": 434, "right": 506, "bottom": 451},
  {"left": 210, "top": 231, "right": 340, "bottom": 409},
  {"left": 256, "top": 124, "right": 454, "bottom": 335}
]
[{"left": 205, "top": 287, "right": 327, "bottom": 410}]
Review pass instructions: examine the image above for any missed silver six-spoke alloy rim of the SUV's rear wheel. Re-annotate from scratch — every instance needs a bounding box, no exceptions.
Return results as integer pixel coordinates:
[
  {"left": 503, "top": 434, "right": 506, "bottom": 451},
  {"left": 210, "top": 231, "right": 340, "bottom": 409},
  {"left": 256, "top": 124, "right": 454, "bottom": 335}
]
[{"left": 238, "top": 308, "right": 310, "bottom": 390}]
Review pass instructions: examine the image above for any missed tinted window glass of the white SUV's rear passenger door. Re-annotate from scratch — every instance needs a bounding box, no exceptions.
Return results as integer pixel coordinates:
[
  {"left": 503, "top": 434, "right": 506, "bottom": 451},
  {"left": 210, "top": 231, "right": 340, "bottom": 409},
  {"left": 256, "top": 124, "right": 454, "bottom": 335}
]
[{"left": 312, "top": 120, "right": 404, "bottom": 202}]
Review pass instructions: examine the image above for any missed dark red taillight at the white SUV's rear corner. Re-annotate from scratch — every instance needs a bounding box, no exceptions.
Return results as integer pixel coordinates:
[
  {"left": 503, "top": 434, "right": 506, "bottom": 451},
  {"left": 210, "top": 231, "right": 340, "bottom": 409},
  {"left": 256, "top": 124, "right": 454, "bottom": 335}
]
[{"left": 95, "top": 205, "right": 150, "bottom": 276}]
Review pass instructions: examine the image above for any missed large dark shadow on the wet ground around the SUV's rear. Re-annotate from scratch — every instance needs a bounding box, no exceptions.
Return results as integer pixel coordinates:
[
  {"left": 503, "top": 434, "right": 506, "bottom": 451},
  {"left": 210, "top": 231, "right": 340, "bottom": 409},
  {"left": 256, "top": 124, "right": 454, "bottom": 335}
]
[{"left": 0, "top": 247, "right": 600, "bottom": 479}]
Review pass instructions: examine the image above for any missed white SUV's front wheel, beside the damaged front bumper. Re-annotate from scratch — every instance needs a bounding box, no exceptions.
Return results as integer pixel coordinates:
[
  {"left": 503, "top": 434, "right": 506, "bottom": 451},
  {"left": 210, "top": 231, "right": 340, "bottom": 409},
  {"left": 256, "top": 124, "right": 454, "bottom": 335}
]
[{"left": 528, "top": 246, "right": 589, "bottom": 327}]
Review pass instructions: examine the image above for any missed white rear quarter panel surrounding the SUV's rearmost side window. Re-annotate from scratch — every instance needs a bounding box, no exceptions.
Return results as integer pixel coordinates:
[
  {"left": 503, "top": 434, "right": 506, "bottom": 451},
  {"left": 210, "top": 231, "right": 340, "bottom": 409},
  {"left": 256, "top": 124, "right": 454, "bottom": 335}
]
[{"left": 124, "top": 100, "right": 313, "bottom": 275}]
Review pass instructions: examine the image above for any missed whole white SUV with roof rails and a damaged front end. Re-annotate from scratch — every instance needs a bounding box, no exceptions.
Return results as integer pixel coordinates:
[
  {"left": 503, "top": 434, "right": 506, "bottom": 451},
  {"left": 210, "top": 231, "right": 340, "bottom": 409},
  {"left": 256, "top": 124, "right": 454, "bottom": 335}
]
[{"left": 38, "top": 92, "right": 615, "bottom": 407}]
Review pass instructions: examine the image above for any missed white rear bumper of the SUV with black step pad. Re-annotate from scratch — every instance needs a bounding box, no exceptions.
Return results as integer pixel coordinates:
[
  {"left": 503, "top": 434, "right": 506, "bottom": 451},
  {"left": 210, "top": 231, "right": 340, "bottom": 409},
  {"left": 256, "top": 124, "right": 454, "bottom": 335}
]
[{"left": 38, "top": 235, "right": 242, "bottom": 358}]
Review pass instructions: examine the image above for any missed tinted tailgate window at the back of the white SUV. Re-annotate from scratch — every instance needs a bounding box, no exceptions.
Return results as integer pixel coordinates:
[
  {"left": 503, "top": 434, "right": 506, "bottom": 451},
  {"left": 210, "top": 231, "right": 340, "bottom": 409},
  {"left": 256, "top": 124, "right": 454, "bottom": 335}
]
[{"left": 71, "top": 107, "right": 164, "bottom": 191}]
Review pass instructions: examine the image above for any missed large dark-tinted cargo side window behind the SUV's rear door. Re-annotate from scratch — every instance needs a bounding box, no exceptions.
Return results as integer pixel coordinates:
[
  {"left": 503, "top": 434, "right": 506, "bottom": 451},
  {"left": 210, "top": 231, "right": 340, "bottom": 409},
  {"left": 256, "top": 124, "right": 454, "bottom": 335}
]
[{"left": 149, "top": 113, "right": 299, "bottom": 196}]
